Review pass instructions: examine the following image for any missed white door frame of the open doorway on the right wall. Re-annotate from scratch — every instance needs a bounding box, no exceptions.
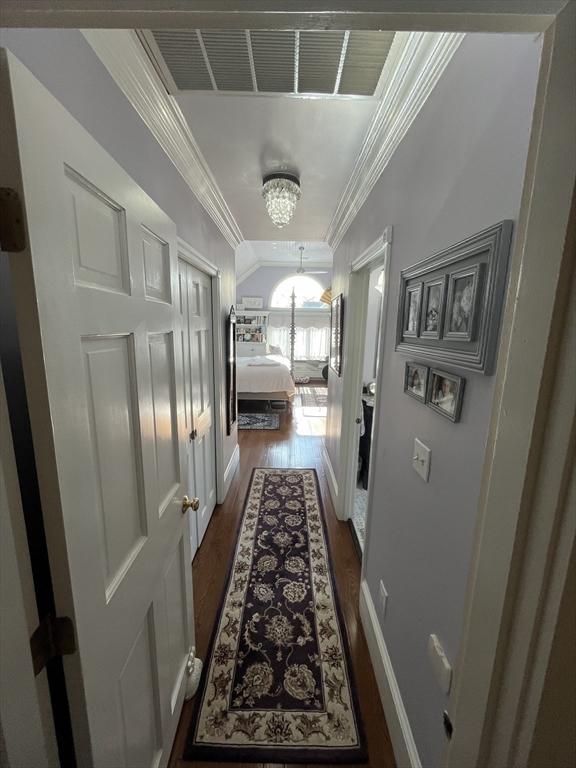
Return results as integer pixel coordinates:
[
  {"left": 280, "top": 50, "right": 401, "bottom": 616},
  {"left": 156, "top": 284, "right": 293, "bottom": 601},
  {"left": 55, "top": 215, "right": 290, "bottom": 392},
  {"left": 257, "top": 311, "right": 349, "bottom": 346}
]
[{"left": 335, "top": 227, "right": 392, "bottom": 520}]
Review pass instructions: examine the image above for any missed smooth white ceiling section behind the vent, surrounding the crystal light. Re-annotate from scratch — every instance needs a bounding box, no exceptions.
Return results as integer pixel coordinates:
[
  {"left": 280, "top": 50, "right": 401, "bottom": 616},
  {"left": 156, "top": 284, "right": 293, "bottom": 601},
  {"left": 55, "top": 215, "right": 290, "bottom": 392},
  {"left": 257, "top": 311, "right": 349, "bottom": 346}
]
[{"left": 176, "top": 92, "right": 377, "bottom": 240}]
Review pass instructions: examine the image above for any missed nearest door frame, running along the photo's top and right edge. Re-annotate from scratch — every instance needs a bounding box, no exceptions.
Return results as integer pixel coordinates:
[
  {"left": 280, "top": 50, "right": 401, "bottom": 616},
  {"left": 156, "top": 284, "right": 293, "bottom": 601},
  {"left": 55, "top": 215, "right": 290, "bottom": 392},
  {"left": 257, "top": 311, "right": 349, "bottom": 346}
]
[{"left": 2, "top": 0, "right": 576, "bottom": 768}]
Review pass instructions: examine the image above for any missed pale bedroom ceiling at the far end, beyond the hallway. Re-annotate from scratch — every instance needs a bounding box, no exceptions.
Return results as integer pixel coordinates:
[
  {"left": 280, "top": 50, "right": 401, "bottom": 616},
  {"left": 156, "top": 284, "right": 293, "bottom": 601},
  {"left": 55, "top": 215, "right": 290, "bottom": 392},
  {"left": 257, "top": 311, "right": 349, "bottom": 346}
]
[{"left": 236, "top": 240, "right": 333, "bottom": 280}]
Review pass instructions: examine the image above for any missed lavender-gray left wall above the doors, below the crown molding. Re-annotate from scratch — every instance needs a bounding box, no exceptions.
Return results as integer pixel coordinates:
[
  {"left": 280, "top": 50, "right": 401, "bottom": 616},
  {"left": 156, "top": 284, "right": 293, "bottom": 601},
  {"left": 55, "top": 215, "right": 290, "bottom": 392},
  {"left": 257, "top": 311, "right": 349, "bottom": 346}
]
[{"left": 0, "top": 29, "right": 237, "bottom": 463}]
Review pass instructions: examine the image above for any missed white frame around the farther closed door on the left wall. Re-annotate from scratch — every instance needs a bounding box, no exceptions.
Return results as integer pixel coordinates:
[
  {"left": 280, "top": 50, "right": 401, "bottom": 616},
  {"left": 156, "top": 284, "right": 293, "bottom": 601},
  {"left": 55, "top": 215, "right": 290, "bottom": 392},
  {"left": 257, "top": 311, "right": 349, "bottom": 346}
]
[{"left": 178, "top": 237, "right": 226, "bottom": 504}]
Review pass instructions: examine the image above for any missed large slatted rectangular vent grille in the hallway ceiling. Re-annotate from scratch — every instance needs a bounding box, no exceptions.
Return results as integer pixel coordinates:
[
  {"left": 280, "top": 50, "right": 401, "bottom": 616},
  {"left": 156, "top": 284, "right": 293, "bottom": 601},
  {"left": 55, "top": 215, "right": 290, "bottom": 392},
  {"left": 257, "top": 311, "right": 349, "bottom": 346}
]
[{"left": 146, "top": 30, "right": 394, "bottom": 97}]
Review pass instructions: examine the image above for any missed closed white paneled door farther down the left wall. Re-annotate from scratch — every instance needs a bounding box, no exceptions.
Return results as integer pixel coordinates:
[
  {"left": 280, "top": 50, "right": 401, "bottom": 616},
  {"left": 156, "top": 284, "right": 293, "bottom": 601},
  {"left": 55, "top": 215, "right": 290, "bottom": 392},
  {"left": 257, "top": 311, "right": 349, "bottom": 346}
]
[{"left": 179, "top": 259, "right": 216, "bottom": 557}]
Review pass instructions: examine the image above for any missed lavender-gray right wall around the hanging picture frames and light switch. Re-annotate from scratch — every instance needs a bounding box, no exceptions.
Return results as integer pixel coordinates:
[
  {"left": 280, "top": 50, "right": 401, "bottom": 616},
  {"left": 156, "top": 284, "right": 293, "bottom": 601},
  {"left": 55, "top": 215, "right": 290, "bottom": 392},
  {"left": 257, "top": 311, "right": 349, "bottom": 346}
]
[{"left": 326, "top": 35, "right": 540, "bottom": 768}]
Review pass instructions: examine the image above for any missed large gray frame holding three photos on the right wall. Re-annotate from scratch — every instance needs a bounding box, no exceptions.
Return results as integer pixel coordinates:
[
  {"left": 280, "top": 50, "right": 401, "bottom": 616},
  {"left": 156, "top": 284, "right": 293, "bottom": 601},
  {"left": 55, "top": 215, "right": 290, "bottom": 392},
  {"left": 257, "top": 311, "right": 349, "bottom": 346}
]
[{"left": 396, "top": 221, "right": 512, "bottom": 375}]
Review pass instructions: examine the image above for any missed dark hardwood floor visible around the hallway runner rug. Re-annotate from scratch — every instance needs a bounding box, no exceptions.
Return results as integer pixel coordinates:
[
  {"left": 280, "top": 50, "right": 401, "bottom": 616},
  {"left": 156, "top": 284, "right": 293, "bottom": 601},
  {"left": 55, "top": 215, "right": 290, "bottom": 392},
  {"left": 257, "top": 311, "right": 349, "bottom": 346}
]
[{"left": 169, "top": 396, "right": 395, "bottom": 768}]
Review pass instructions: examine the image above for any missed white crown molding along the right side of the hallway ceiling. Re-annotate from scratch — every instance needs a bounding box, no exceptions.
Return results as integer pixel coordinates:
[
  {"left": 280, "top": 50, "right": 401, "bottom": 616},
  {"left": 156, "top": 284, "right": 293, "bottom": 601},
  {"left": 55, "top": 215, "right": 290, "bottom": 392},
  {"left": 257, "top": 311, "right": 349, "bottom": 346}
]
[{"left": 324, "top": 32, "right": 465, "bottom": 250}]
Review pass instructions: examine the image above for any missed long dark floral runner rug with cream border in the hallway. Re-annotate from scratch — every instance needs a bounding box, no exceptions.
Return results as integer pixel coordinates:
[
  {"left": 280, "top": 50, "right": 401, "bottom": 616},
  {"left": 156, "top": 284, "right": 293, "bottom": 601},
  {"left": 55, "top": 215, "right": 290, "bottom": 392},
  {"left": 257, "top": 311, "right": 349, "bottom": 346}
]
[{"left": 184, "top": 469, "right": 366, "bottom": 763}]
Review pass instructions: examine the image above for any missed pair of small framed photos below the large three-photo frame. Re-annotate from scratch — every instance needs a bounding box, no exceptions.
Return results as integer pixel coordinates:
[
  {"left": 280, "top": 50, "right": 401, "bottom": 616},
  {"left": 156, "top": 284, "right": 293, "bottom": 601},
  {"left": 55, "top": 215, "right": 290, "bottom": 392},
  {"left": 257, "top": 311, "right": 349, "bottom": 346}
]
[{"left": 404, "top": 362, "right": 466, "bottom": 423}]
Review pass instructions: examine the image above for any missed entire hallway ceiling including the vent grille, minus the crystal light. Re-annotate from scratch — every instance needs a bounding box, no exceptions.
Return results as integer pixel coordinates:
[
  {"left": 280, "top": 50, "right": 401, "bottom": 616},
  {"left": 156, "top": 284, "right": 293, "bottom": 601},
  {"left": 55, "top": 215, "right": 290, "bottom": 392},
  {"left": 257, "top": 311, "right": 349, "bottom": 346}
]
[{"left": 139, "top": 29, "right": 395, "bottom": 249}]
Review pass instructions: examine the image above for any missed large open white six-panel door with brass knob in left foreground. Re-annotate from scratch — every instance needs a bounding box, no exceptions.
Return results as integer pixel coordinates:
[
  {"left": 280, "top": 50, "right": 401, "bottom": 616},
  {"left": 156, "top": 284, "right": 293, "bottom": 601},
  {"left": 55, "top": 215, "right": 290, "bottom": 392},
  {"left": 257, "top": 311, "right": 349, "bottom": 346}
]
[{"left": 1, "top": 54, "right": 195, "bottom": 768}]
